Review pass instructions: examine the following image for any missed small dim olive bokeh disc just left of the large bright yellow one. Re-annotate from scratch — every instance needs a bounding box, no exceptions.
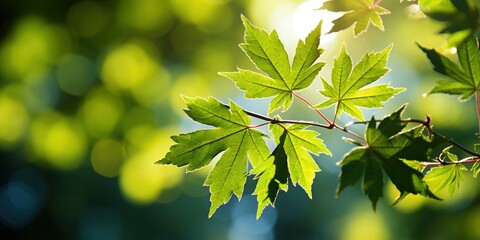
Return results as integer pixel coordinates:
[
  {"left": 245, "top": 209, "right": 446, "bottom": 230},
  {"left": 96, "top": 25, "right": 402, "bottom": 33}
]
[{"left": 91, "top": 139, "right": 125, "bottom": 177}]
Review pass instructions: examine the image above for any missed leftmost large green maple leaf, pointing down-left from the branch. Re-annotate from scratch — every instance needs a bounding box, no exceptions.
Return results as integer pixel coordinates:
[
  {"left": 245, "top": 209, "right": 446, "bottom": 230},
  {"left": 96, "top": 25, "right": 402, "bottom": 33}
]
[{"left": 157, "top": 98, "right": 270, "bottom": 217}]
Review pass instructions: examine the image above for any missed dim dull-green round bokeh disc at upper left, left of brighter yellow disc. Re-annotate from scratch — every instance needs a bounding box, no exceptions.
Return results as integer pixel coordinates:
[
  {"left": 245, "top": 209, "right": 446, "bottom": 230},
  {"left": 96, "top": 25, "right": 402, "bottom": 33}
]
[{"left": 57, "top": 55, "right": 95, "bottom": 96}]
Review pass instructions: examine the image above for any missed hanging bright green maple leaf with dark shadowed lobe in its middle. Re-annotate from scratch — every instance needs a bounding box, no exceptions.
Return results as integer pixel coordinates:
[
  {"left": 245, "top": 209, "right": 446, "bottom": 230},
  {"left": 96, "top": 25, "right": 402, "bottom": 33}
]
[{"left": 251, "top": 124, "right": 331, "bottom": 217}]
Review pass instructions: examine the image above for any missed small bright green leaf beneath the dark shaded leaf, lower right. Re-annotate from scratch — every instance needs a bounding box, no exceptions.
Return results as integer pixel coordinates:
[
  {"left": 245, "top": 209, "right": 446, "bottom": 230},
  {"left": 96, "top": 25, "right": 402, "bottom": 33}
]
[{"left": 424, "top": 164, "right": 467, "bottom": 197}]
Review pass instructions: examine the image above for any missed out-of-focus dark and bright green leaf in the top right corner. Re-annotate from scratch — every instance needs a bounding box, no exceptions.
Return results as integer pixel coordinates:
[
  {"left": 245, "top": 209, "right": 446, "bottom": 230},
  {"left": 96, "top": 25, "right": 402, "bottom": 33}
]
[{"left": 418, "top": 0, "right": 480, "bottom": 46}]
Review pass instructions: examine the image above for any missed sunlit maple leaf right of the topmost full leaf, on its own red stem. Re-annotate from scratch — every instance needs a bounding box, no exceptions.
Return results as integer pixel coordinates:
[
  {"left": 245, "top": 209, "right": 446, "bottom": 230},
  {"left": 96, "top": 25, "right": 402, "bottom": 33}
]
[{"left": 316, "top": 45, "right": 405, "bottom": 121}]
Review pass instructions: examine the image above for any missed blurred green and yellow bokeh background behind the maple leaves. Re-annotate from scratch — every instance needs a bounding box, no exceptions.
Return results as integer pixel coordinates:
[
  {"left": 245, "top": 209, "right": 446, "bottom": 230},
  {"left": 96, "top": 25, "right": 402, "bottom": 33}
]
[{"left": 0, "top": 0, "right": 480, "bottom": 240}]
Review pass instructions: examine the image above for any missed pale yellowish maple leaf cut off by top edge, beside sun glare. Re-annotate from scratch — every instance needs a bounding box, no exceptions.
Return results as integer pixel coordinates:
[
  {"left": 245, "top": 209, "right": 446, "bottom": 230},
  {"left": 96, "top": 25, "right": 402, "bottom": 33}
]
[{"left": 320, "top": 0, "right": 390, "bottom": 36}]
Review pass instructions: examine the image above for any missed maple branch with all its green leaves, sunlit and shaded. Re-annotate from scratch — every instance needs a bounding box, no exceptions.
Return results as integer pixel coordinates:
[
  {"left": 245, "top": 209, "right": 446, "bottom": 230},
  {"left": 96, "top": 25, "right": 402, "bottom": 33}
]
[{"left": 157, "top": 0, "right": 480, "bottom": 218}]
